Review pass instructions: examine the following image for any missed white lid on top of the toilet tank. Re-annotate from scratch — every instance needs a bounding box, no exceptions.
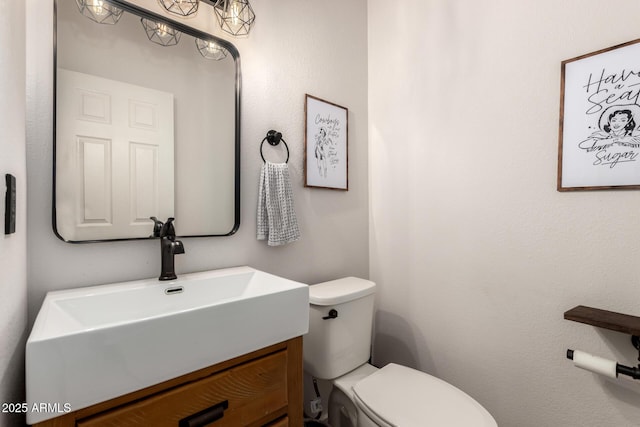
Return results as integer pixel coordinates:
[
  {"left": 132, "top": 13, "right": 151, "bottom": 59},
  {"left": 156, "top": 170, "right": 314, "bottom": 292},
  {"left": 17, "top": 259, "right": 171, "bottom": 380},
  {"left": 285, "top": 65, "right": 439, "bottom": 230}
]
[{"left": 309, "top": 277, "right": 376, "bottom": 305}]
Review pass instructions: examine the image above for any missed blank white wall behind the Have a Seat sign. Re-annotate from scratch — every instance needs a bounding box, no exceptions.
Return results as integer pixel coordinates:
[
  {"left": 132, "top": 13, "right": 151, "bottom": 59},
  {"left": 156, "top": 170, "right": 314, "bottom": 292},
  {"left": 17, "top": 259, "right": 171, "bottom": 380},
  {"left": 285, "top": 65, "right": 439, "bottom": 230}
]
[{"left": 368, "top": 0, "right": 640, "bottom": 427}]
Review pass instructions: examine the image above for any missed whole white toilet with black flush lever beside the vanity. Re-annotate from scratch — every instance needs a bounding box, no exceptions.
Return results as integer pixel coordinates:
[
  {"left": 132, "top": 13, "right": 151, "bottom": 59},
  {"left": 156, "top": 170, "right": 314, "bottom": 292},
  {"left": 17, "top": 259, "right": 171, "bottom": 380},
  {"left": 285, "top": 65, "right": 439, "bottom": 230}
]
[{"left": 303, "top": 277, "right": 497, "bottom": 427}]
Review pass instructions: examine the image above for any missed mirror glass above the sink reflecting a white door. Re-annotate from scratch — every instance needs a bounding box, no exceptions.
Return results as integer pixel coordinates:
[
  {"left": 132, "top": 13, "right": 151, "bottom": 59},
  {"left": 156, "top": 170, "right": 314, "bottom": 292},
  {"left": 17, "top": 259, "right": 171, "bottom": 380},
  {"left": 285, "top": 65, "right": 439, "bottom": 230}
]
[{"left": 54, "top": 0, "right": 240, "bottom": 242}]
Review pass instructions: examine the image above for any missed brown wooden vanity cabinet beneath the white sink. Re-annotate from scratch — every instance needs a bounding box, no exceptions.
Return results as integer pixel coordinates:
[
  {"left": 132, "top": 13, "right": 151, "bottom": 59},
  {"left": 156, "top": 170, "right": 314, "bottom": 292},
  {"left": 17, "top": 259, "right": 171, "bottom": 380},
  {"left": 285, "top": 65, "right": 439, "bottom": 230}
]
[{"left": 35, "top": 337, "right": 303, "bottom": 427}]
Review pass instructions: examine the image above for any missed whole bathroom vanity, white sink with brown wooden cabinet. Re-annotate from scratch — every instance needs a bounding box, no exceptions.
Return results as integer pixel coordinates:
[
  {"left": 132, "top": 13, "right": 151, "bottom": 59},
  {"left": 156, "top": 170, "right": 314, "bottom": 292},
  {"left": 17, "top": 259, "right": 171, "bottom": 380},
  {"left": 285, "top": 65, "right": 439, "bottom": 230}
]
[{"left": 26, "top": 267, "right": 309, "bottom": 427}]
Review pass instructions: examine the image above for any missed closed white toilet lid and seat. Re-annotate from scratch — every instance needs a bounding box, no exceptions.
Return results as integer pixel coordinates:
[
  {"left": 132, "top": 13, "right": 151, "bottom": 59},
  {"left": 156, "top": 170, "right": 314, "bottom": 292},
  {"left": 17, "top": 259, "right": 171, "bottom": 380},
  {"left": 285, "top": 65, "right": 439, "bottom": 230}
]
[{"left": 353, "top": 363, "right": 497, "bottom": 427}]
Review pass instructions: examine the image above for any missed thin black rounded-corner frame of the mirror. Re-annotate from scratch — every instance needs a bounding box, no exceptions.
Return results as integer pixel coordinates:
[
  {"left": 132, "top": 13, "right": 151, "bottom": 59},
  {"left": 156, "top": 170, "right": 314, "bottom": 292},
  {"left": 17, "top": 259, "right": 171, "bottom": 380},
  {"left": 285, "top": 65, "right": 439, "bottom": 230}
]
[{"left": 52, "top": 0, "right": 242, "bottom": 243}]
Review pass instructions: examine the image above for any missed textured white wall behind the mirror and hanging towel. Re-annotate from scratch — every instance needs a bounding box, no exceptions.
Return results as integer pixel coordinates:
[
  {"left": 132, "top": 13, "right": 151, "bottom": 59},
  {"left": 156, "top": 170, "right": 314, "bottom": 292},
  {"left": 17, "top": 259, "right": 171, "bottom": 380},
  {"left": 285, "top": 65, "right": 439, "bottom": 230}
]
[{"left": 27, "top": 0, "right": 369, "bottom": 319}]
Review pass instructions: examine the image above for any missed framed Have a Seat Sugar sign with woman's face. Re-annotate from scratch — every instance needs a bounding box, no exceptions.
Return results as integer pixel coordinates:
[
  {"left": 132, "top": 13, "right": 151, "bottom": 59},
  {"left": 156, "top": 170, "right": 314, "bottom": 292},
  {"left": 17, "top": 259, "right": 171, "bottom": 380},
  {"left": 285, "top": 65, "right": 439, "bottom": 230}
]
[{"left": 557, "top": 40, "right": 640, "bottom": 191}]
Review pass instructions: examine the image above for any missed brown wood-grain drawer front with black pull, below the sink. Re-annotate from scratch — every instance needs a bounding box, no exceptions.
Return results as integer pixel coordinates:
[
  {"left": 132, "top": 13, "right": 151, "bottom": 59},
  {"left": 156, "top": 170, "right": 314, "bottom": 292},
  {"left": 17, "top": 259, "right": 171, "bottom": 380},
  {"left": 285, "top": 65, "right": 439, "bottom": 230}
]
[{"left": 77, "top": 352, "right": 287, "bottom": 427}]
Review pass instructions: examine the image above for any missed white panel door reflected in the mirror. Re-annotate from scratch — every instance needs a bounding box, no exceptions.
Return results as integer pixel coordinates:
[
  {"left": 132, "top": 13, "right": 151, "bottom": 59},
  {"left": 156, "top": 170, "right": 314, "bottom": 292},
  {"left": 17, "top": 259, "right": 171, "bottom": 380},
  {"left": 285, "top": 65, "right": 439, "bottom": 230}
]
[{"left": 56, "top": 69, "right": 174, "bottom": 241}]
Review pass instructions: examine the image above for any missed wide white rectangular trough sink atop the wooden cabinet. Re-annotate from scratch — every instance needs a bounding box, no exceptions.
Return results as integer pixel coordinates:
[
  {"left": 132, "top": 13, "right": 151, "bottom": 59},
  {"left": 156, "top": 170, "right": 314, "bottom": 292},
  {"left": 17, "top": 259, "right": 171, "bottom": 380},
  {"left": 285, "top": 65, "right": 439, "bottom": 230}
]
[{"left": 26, "top": 267, "right": 309, "bottom": 424}]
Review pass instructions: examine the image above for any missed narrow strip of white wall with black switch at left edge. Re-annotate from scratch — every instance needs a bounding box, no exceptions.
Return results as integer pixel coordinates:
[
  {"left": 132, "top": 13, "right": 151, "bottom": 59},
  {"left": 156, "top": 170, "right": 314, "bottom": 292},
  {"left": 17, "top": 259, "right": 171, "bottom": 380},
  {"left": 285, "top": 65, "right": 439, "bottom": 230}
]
[{"left": 0, "top": 2, "right": 27, "bottom": 427}]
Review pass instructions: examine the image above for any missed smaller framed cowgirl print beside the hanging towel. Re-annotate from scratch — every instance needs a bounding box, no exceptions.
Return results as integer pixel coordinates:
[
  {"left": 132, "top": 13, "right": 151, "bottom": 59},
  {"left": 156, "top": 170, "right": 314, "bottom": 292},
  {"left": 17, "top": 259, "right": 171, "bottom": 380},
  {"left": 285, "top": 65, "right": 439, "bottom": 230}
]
[{"left": 304, "top": 94, "right": 349, "bottom": 191}]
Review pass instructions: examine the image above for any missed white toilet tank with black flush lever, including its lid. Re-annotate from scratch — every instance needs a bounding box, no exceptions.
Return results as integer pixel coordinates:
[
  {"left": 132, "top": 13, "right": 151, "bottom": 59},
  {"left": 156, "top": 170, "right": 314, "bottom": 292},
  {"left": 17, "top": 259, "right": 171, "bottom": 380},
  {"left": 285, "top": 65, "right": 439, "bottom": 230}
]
[{"left": 303, "top": 277, "right": 376, "bottom": 380}]
